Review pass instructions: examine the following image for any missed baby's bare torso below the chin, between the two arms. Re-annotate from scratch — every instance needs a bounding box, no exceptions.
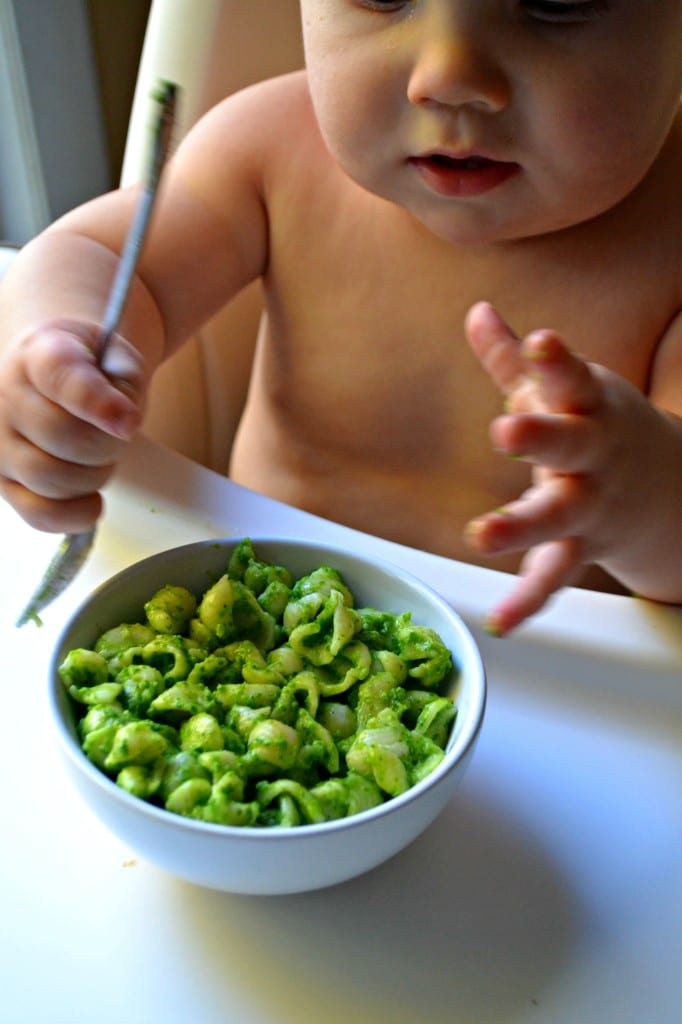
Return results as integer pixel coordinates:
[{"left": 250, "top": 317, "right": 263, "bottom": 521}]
[{"left": 227, "top": 74, "right": 682, "bottom": 585}]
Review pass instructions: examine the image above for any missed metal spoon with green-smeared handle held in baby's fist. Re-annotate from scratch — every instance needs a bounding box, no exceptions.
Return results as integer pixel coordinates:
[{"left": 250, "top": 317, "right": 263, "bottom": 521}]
[{"left": 16, "top": 82, "right": 177, "bottom": 627}]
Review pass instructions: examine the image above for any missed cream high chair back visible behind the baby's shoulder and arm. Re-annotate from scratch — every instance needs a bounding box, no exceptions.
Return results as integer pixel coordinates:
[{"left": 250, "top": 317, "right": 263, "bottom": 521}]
[{"left": 122, "top": 0, "right": 303, "bottom": 473}]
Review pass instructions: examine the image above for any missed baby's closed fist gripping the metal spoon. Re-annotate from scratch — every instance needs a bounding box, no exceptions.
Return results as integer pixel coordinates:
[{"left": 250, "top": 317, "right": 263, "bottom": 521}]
[{"left": 0, "top": 322, "right": 144, "bottom": 534}]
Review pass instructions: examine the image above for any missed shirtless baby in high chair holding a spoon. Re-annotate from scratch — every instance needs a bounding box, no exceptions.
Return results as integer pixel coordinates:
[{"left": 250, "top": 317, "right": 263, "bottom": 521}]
[{"left": 0, "top": 0, "right": 682, "bottom": 635}]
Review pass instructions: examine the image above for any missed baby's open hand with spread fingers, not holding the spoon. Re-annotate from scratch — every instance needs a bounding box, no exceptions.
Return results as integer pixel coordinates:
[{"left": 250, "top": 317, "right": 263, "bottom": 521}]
[{"left": 466, "top": 303, "right": 658, "bottom": 636}]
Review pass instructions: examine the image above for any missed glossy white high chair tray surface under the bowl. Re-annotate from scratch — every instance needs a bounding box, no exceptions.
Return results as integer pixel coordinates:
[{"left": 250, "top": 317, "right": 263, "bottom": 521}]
[{"left": 0, "top": 440, "right": 682, "bottom": 1024}]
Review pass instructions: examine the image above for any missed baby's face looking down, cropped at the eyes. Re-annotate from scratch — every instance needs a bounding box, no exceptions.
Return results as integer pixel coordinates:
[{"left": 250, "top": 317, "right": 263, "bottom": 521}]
[{"left": 301, "top": 0, "right": 682, "bottom": 244}]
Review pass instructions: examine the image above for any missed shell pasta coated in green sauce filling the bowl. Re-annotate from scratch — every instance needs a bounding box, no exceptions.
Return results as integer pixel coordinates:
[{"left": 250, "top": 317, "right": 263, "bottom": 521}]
[{"left": 59, "top": 539, "right": 457, "bottom": 827}]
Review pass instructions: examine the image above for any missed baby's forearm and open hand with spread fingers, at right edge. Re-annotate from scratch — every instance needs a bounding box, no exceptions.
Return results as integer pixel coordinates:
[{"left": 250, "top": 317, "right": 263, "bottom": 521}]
[{"left": 467, "top": 303, "right": 682, "bottom": 636}]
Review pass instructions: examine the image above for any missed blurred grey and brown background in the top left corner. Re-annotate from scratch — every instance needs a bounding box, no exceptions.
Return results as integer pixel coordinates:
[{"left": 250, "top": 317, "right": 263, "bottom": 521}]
[{"left": 0, "top": 0, "right": 150, "bottom": 245}]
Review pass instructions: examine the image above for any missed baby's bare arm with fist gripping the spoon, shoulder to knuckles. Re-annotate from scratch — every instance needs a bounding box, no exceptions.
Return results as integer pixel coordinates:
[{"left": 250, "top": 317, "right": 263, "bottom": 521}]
[{"left": 0, "top": 75, "right": 282, "bottom": 532}]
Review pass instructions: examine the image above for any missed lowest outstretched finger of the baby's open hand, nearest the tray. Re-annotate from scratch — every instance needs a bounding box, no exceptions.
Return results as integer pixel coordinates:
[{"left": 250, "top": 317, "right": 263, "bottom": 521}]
[{"left": 486, "top": 538, "right": 583, "bottom": 637}]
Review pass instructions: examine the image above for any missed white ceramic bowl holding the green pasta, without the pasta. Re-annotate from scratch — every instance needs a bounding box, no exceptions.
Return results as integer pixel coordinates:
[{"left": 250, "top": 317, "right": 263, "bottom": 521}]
[{"left": 49, "top": 538, "right": 485, "bottom": 894}]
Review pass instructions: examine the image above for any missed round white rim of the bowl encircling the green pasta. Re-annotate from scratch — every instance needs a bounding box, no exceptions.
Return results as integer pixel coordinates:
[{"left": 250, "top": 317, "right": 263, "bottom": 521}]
[{"left": 48, "top": 534, "right": 487, "bottom": 843}]
